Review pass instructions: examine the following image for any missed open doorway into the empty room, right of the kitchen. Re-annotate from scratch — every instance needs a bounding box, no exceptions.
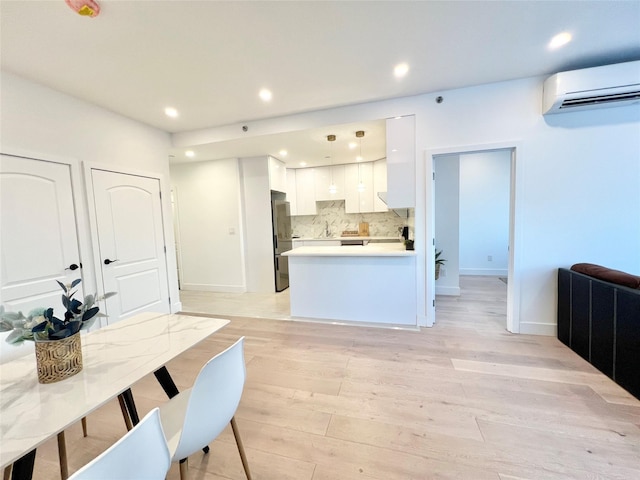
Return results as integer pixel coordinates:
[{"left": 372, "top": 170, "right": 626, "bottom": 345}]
[{"left": 433, "top": 149, "right": 511, "bottom": 329}]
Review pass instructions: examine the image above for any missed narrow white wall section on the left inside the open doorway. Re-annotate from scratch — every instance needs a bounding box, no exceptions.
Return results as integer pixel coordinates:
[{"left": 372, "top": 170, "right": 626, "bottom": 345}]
[{"left": 433, "top": 155, "right": 460, "bottom": 295}]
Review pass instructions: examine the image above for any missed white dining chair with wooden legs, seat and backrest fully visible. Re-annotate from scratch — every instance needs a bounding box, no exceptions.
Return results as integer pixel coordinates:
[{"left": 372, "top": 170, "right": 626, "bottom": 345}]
[{"left": 160, "top": 337, "right": 251, "bottom": 480}]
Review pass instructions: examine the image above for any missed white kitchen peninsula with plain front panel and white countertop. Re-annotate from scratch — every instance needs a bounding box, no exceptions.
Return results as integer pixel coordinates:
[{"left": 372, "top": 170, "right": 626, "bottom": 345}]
[{"left": 283, "top": 242, "right": 416, "bottom": 326}]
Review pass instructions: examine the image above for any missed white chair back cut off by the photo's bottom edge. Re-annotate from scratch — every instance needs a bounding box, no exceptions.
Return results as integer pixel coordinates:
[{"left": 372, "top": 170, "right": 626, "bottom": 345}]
[{"left": 69, "top": 408, "right": 171, "bottom": 480}]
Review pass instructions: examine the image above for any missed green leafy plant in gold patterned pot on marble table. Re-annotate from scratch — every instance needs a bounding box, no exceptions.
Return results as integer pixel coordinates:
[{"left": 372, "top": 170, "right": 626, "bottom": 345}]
[{"left": 0, "top": 278, "right": 115, "bottom": 383}]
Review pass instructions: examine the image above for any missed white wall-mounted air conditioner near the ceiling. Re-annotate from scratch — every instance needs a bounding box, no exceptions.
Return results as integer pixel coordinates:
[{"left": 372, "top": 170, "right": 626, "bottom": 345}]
[{"left": 542, "top": 61, "right": 640, "bottom": 115}]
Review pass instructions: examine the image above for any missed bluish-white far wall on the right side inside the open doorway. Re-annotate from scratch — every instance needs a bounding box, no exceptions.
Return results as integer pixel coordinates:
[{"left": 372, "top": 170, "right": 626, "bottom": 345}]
[{"left": 460, "top": 150, "right": 511, "bottom": 276}]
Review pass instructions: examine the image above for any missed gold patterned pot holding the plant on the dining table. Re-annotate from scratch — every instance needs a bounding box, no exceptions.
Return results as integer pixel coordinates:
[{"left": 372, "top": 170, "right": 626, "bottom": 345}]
[{"left": 35, "top": 332, "right": 82, "bottom": 383}]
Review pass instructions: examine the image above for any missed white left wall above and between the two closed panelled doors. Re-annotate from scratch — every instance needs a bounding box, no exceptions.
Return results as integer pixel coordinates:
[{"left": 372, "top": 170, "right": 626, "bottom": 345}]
[{"left": 0, "top": 72, "right": 180, "bottom": 311}]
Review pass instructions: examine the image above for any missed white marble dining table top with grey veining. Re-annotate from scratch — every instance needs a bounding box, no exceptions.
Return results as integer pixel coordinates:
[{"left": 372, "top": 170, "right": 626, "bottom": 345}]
[{"left": 0, "top": 313, "right": 229, "bottom": 468}]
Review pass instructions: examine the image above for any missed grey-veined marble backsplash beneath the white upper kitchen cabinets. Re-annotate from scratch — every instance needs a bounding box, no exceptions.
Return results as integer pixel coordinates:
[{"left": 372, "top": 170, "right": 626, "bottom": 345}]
[{"left": 291, "top": 200, "right": 414, "bottom": 238}]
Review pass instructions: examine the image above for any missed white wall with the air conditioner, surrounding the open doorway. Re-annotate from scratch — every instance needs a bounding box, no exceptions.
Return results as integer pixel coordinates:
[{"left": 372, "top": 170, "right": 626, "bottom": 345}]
[{"left": 174, "top": 78, "right": 640, "bottom": 334}]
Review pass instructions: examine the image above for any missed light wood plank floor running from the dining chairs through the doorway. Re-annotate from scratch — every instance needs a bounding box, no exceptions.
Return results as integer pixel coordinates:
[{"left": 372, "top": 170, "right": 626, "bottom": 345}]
[{"left": 27, "top": 278, "right": 640, "bottom": 480}]
